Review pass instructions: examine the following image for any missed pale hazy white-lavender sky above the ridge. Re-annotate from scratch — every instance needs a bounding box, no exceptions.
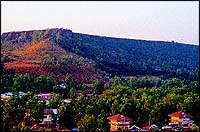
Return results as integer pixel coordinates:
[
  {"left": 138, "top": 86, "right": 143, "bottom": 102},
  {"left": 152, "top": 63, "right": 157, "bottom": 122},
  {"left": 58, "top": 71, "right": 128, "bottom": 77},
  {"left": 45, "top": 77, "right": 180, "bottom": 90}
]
[{"left": 1, "top": 1, "right": 199, "bottom": 45}]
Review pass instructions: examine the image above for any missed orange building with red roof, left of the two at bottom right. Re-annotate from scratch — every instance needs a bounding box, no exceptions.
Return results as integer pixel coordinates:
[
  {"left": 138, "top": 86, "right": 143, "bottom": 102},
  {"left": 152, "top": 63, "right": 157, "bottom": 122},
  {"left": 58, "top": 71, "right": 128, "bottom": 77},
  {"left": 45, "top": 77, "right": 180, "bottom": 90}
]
[{"left": 107, "top": 114, "right": 132, "bottom": 131}]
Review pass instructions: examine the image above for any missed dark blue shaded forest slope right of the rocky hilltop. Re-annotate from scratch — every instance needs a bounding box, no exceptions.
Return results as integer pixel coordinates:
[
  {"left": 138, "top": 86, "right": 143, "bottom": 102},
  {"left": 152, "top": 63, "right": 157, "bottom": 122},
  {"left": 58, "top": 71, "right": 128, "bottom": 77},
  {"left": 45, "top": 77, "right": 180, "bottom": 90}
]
[{"left": 69, "top": 33, "right": 199, "bottom": 78}]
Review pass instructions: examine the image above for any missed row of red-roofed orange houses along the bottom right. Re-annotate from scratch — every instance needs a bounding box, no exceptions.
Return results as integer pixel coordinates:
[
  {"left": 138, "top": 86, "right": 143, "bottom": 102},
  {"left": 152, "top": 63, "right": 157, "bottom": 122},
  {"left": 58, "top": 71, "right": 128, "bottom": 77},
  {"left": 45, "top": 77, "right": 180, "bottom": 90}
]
[{"left": 107, "top": 111, "right": 194, "bottom": 131}]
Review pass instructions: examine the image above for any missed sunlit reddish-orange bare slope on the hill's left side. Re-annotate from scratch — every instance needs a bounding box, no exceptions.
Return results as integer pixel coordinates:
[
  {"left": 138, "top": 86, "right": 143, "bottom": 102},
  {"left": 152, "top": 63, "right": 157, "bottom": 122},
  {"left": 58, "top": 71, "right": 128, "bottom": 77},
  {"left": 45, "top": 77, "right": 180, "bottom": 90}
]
[{"left": 3, "top": 37, "right": 102, "bottom": 83}]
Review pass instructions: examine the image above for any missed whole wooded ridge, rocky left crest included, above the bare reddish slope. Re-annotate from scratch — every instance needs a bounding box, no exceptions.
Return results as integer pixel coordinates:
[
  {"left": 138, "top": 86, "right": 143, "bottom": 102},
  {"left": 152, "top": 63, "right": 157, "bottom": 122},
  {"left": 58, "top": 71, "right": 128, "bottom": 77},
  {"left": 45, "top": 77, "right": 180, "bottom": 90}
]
[{"left": 1, "top": 28, "right": 199, "bottom": 80}]
